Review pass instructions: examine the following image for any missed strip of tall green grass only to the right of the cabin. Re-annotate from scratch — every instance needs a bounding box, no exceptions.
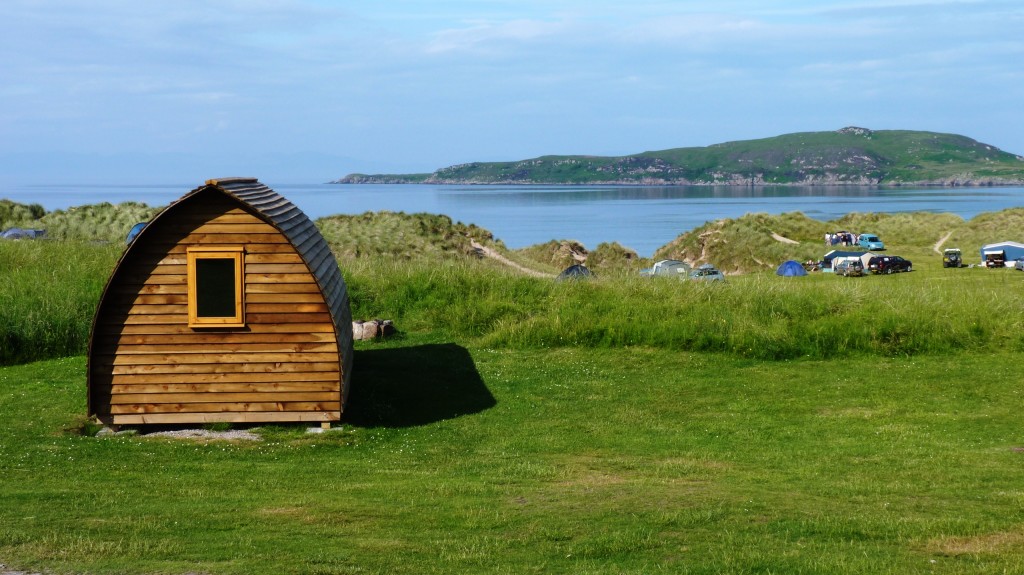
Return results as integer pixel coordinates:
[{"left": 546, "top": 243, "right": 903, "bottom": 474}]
[{"left": 348, "top": 255, "right": 1024, "bottom": 360}]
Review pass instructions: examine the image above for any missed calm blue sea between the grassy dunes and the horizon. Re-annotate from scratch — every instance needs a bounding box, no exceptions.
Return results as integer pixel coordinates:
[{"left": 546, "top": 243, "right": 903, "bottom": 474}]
[{"left": 0, "top": 181, "right": 1024, "bottom": 256}]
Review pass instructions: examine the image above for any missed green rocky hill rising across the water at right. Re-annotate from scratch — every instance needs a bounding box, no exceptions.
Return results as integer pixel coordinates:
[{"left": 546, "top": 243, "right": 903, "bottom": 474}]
[{"left": 334, "top": 127, "right": 1024, "bottom": 185}]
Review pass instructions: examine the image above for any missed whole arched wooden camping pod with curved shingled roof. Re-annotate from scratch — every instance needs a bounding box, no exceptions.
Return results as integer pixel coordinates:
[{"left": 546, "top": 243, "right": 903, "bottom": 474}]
[{"left": 87, "top": 178, "right": 352, "bottom": 425}]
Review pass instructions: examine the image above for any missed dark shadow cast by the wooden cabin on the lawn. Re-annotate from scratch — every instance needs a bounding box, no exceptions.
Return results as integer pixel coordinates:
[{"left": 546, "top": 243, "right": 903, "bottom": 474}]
[{"left": 345, "top": 344, "right": 498, "bottom": 428}]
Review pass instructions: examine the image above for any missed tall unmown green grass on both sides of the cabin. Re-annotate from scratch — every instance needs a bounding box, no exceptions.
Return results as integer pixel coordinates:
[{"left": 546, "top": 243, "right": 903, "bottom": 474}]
[{"left": 0, "top": 216, "right": 1024, "bottom": 364}]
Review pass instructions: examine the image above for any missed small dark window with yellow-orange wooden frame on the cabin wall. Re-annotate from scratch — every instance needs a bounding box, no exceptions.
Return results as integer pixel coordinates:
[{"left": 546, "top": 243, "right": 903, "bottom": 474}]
[{"left": 187, "top": 247, "right": 245, "bottom": 327}]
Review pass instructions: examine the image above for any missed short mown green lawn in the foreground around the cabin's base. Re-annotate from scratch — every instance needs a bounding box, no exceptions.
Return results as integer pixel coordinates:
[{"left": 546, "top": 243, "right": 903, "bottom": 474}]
[{"left": 0, "top": 335, "right": 1024, "bottom": 574}]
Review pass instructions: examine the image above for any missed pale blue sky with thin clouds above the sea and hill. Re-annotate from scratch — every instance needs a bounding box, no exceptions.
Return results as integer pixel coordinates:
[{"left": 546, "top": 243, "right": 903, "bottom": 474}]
[{"left": 0, "top": 0, "right": 1024, "bottom": 184}]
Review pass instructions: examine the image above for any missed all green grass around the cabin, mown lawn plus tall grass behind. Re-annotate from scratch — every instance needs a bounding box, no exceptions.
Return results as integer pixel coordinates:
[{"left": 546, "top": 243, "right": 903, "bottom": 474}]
[{"left": 0, "top": 209, "right": 1024, "bottom": 574}]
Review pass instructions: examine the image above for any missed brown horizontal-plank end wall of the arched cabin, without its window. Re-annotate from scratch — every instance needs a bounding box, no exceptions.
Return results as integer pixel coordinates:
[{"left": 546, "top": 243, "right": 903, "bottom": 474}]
[{"left": 90, "top": 194, "right": 342, "bottom": 425}]
